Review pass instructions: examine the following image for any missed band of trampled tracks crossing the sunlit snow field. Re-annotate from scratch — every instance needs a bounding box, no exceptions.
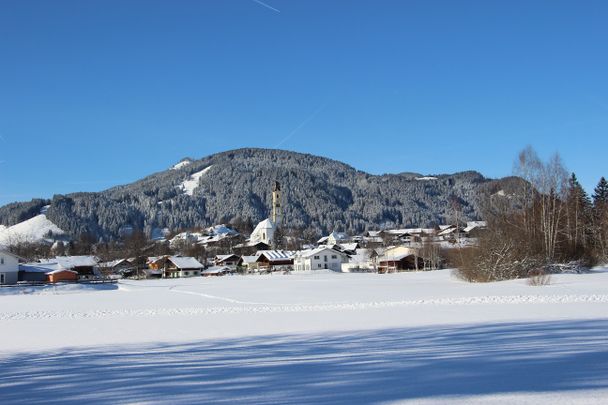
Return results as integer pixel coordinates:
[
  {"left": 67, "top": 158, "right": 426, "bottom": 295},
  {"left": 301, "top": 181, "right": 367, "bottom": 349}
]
[{"left": 0, "top": 290, "right": 608, "bottom": 321}]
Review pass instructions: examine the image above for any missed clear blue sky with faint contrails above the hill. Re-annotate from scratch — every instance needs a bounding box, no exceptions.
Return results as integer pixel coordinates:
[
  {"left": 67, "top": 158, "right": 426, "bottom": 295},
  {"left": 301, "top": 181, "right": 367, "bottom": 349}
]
[{"left": 0, "top": 0, "right": 608, "bottom": 204}]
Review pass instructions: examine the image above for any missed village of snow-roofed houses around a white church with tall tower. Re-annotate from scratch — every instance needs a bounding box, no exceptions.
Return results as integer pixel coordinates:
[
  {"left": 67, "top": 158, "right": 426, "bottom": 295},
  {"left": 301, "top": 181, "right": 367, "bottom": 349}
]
[{"left": 0, "top": 183, "right": 486, "bottom": 286}]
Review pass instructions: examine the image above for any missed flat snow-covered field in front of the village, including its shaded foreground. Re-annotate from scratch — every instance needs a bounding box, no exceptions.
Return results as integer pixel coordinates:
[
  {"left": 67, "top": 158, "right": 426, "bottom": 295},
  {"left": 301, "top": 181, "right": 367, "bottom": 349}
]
[{"left": 0, "top": 270, "right": 608, "bottom": 404}]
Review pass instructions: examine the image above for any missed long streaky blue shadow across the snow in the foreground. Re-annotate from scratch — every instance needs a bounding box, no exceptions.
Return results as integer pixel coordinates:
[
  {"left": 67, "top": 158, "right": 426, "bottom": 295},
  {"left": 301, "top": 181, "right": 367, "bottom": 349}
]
[{"left": 0, "top": 320, "right": 608, "bottom": 404}]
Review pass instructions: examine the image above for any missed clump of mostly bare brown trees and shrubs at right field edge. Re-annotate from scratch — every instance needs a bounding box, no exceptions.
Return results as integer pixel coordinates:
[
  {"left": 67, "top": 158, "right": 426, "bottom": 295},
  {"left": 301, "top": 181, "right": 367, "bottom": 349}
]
[{"left": 457, "top": 147, "right": 608, "bottom": 281}]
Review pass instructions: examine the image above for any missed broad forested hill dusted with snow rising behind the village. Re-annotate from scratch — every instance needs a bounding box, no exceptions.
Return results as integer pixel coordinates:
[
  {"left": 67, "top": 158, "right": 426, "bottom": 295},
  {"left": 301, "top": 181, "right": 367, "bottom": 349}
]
[{"left": 0, "top": 149, "right": 516, "bottom": 239}]
